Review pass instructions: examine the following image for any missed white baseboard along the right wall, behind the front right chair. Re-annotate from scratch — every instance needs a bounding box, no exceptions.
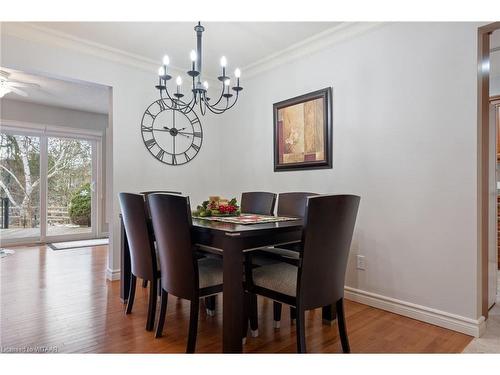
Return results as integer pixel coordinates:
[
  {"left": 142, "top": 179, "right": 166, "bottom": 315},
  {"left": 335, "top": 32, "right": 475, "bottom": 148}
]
[{"left": 345, "top": 286, "right": 486, "bottom": 337}]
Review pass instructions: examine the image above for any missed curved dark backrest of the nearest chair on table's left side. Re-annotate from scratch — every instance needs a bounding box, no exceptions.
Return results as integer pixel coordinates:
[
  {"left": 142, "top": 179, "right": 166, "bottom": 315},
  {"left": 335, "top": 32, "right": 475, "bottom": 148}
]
[{"left": 148, "top": 194, "right": 199, "bottom": 300}]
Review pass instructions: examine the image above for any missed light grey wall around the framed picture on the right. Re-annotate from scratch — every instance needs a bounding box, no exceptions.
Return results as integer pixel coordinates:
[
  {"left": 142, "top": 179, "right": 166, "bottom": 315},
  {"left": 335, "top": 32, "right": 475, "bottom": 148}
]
[{"left": 221, "top": 23, "right": 480, "bottom": 319}]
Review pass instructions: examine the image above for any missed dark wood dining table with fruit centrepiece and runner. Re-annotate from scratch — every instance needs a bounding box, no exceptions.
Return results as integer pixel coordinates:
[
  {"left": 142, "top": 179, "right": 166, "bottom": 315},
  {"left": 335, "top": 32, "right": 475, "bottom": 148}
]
[{"left": 120, "top": 216, "right": 334, "bottom": 353}]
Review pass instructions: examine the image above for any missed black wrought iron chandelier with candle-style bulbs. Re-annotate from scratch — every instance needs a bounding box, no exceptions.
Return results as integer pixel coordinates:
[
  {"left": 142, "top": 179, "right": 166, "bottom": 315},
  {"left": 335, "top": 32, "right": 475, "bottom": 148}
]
[{"left": 155, "top": 22, "right": 243, "bottom": 115}]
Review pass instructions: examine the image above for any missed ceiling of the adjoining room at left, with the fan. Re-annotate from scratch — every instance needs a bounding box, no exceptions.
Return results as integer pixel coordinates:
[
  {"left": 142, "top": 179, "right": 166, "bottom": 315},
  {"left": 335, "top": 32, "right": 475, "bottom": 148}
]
[{"left": 0, "top": 67, "right": 109, "bottom": 114}]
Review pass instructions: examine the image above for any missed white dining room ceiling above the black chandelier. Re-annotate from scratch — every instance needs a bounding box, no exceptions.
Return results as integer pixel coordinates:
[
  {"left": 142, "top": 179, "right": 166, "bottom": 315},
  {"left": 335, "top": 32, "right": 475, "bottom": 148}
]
[{"left": 32, "top": 22, "right": 341, "bottom": 77}]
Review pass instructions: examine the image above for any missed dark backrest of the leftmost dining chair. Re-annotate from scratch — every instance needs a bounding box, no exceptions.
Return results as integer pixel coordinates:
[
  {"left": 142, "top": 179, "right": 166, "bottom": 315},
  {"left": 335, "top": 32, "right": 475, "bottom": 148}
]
[{"left": 119, "top": 193, "right": 157, "bottom": 280}]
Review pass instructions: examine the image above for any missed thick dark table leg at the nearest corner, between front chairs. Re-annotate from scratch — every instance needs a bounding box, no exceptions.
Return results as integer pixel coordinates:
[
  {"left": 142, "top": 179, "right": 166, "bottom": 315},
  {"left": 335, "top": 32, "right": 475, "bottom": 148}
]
[{"left": 222, "top": 236, "right": 243, "bottom": 353}]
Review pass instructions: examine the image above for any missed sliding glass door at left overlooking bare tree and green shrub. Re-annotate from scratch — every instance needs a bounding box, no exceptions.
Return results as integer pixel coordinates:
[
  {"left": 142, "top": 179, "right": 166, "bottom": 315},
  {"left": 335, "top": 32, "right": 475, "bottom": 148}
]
[{"left": 0, "top": 129, "right": 98, "bottom": 245}]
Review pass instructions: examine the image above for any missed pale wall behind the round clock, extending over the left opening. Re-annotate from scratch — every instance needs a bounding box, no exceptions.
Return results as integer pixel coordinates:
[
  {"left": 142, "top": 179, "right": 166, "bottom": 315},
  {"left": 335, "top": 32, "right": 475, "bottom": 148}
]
[{"left": 0, "top": 23, "right": 220, "bottom": 274}]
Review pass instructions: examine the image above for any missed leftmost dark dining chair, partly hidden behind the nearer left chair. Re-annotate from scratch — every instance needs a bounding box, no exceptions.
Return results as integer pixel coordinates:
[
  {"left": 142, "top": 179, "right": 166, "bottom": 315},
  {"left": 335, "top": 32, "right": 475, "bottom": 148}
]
[{"left": 119, "top": 193, "right": 160, "bottom": 331}]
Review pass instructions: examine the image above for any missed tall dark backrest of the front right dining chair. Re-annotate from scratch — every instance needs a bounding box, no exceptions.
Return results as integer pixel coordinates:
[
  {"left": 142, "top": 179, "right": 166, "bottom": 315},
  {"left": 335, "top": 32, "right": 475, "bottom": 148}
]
[{"left": 297, "top": 195, "right": 360, "bottom": 309}]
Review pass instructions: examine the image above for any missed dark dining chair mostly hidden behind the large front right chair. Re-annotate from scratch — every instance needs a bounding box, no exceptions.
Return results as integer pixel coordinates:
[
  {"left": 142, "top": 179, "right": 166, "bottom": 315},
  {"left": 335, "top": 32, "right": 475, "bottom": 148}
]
[{"left": 249, "top": 192, "right": 318, "bottom": 330}]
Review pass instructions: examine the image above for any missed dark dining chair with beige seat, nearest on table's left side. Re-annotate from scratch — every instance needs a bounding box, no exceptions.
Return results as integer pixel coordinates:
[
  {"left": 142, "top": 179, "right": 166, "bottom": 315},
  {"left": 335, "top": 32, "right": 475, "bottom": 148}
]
[{"left": 148, "top": 194, "right": 222, "bottom": 353}]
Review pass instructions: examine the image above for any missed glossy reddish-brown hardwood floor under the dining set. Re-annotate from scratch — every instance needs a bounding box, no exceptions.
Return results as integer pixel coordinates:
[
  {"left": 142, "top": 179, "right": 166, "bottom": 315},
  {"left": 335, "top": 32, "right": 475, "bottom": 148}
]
[{"left": 0, "top": 246, "right": 471, "bottom": 353}]
